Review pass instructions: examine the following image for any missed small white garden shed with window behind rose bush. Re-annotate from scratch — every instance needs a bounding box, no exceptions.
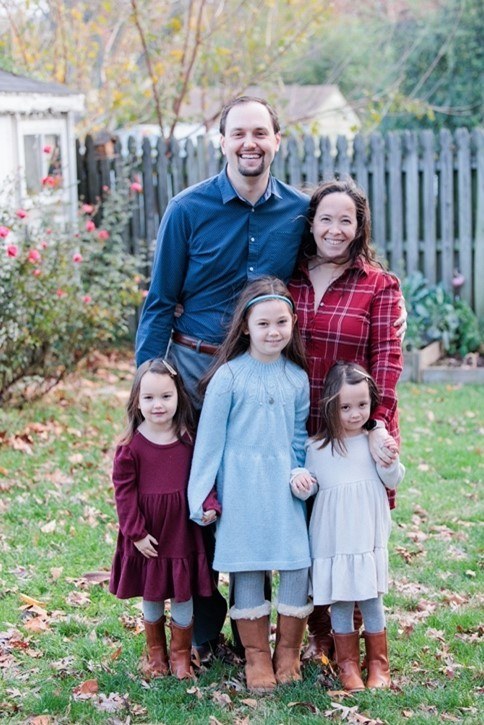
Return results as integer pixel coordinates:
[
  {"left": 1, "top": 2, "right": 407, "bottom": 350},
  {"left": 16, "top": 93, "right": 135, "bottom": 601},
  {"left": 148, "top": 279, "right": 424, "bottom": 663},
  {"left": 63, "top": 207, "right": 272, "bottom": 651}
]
[{"left": 0, "top": 70, "right": 84, "bottom": 220}]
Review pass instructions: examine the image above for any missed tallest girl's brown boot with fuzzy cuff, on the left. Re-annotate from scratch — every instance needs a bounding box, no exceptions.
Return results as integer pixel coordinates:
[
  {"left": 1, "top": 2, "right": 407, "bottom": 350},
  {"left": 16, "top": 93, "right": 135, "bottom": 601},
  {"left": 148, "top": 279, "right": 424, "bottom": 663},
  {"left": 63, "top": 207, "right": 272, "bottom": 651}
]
[{"left": 237, "top": 615, "right": 276, "bottom": 693}]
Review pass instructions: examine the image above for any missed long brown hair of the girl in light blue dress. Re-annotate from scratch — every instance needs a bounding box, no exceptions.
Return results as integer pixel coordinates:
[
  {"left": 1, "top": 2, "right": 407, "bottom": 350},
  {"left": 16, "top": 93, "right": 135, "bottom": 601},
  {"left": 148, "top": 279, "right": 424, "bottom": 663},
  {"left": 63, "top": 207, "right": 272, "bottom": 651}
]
[{"left": 200, "top": 276, "right": 307, "bottom": 392}]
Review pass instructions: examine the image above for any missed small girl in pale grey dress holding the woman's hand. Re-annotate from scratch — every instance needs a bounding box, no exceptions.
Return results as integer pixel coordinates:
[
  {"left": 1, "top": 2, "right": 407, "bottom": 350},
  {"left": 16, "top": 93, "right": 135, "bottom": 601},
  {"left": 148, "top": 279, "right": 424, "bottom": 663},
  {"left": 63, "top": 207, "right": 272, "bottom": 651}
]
[{"left": 291, "top": 362, "right": 405, "bottom": 692}]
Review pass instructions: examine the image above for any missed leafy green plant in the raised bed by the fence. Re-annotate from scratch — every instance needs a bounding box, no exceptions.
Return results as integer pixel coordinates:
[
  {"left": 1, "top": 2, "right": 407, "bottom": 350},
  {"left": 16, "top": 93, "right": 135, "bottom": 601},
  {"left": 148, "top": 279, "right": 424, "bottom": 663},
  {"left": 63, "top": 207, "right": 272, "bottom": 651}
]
[{"left": 402, "top": 272, "right": 482, "bottom": 355}]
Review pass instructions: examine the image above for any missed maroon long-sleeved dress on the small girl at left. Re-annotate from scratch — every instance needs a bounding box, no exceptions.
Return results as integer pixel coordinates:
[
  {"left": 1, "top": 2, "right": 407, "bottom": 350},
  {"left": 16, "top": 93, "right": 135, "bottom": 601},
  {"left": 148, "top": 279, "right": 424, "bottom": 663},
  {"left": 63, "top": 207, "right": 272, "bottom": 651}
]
[{"left": 109, "top": 431, "right": 213, "bottom": 602}]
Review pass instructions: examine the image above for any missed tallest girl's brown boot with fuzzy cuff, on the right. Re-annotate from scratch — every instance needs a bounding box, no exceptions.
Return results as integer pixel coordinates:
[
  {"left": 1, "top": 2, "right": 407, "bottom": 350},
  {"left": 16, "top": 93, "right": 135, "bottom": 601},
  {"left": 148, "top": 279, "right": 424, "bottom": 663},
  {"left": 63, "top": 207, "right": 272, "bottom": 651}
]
[{"left": 272, "top": 614, "right": 307, "bottom": 685}]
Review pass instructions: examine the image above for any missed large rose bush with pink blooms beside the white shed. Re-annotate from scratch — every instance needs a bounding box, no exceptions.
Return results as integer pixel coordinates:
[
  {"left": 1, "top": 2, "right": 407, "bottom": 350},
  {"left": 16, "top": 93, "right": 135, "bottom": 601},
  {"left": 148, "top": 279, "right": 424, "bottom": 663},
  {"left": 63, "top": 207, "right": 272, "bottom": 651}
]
[{"left": 0, "top": 187, "right": 141, "bottom": 403}]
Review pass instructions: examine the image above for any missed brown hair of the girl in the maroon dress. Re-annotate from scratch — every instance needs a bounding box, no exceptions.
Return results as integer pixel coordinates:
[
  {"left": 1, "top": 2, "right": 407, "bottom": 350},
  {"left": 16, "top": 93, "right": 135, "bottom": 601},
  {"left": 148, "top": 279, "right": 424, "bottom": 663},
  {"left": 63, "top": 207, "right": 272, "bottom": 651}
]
[{"left": 118, "top": 358, "right": 195, "bottom": 445}]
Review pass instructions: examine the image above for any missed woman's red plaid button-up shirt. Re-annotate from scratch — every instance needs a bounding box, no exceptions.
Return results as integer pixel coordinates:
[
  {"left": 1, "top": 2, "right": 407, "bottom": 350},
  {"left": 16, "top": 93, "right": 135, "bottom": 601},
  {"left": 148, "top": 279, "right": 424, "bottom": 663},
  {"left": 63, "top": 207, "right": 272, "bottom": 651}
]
[{"left": 289, "top": 260, "right": 403, "bottom": 507}]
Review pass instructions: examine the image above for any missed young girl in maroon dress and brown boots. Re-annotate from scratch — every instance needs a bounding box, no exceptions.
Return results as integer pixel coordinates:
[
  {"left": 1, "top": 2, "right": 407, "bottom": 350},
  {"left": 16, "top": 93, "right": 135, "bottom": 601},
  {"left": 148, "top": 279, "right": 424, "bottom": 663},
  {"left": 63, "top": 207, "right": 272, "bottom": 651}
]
[{"left": 109, "top": 359, "right": 219, "bottom": 679}]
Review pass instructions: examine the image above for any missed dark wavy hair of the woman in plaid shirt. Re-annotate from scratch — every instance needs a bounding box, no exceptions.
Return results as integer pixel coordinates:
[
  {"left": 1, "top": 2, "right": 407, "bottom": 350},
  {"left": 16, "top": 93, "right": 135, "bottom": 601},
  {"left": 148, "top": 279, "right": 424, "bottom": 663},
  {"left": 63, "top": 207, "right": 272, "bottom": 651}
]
[{"left": 300, "top": 178, "right": 383, "bottom": 267}]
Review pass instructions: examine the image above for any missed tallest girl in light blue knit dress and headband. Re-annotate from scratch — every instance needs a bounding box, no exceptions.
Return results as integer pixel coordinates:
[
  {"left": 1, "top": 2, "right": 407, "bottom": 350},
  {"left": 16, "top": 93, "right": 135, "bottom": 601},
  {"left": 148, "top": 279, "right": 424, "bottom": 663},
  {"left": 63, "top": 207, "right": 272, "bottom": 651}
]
[{"left": 188, "top": 277, "right": 312, "bottom": 692}]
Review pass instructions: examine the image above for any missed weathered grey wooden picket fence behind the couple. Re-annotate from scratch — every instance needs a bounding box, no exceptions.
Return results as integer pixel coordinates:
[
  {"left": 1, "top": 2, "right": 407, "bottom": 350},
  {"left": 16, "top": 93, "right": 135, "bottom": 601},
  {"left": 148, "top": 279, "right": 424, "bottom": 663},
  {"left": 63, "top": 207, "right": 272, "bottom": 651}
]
[{"left": 77, "top": 128, "right": 484, "bottom": 317}]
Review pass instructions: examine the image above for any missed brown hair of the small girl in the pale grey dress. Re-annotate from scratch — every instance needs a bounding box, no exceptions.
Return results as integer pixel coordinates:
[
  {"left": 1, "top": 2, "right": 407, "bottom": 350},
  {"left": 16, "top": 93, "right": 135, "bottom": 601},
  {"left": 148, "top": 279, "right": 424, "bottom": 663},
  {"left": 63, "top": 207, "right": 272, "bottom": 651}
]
[{"left": 314, "top": 362, "right": 380, "bottom": 453}]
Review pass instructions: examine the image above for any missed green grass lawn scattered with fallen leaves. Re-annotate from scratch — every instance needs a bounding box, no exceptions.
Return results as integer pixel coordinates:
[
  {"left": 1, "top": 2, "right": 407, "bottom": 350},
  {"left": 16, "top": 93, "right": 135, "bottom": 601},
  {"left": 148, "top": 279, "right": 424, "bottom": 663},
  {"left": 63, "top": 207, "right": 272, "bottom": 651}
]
[{"left": 0, "top": 356, "right": 484, "bottom": 725}]
